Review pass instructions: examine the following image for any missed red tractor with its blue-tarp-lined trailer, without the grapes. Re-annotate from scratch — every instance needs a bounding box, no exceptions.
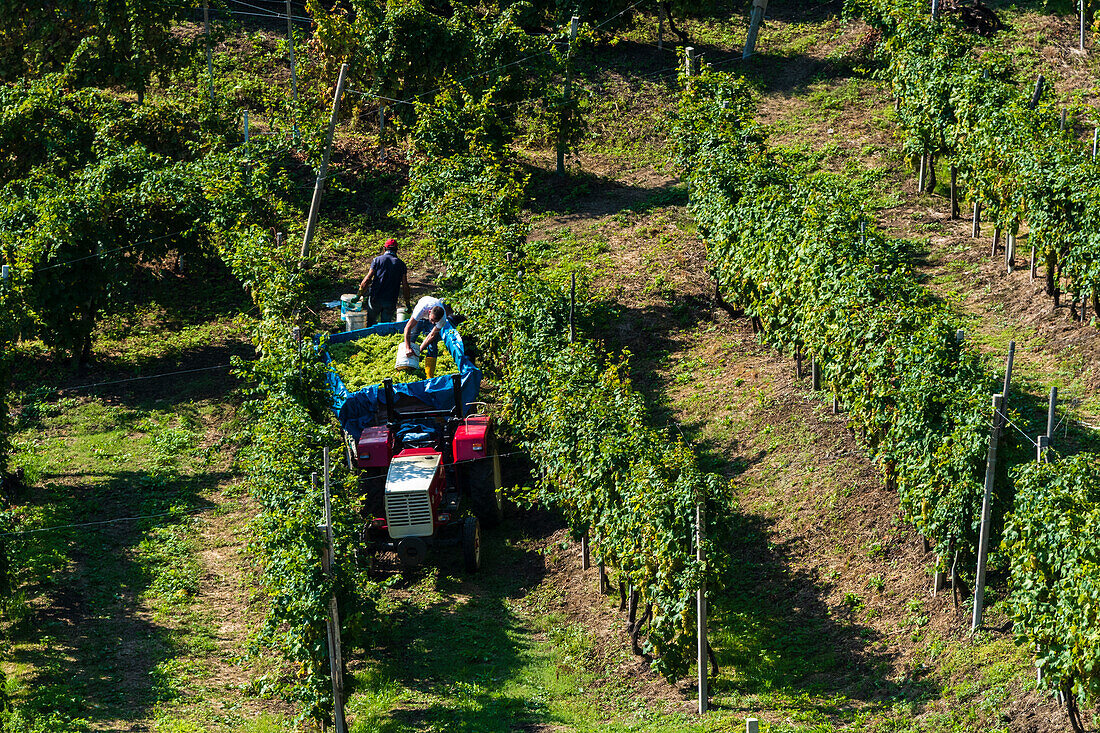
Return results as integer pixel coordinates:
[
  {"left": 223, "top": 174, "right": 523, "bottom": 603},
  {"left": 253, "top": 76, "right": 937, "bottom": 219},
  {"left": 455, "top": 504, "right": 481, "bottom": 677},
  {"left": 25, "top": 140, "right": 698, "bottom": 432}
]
[{"left": 319, "top": 321, "right": 503, "bottom": 572}]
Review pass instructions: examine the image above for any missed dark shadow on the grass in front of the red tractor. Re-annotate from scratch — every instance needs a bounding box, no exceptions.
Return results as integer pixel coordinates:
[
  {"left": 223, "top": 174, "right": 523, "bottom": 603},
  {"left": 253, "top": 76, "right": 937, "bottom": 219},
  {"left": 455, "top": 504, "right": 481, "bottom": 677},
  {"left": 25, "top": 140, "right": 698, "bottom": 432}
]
[{"left": 352, "top": 512, "right": 561, "bottom": 733}]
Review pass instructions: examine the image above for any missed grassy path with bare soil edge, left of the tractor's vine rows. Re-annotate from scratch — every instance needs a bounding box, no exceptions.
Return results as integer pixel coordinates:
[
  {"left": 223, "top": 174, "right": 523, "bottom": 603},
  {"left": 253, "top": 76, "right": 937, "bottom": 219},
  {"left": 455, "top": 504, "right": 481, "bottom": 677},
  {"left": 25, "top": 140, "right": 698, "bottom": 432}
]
[{"left": 2, "top": 352, "right": 278, "bottom": 731}]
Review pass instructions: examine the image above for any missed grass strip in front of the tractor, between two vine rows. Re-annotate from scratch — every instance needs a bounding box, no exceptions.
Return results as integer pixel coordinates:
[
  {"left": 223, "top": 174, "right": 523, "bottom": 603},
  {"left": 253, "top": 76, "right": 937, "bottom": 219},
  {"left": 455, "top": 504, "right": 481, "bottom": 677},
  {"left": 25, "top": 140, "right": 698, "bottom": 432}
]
[{"left": 348, "top": 528, "right": 704, "bottom": 733}]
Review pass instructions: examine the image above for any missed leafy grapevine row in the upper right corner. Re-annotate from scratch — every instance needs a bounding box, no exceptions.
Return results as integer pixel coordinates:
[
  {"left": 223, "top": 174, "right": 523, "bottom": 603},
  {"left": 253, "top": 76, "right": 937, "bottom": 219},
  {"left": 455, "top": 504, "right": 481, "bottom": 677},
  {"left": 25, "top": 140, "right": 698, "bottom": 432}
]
[{"left": 849, "top": 0, "right": 1100, "bottom": 306}]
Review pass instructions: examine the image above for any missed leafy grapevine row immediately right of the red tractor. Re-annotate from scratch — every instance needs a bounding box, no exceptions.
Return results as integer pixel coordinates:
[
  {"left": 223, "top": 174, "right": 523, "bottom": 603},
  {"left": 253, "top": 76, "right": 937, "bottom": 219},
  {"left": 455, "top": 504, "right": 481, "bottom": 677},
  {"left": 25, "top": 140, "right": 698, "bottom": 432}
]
[{"left": 403, "top": 145, "right": 729, "bottom": 677}]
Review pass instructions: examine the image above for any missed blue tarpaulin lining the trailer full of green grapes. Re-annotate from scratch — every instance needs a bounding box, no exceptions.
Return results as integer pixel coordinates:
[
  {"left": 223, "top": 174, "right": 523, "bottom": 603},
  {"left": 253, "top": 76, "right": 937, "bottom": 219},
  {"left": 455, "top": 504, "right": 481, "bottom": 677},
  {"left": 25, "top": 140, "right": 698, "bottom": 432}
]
[{"left": 314, "top": 320, "right": 481, "bottom": 440}]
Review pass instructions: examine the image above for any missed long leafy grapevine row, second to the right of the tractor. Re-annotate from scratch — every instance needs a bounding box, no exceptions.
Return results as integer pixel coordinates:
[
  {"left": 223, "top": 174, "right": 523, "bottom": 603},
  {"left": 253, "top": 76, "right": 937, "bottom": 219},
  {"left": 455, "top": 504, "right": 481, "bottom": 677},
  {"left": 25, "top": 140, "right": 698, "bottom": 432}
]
[{"left": 674, "top": 64, "right": 994, "bottom": 557}]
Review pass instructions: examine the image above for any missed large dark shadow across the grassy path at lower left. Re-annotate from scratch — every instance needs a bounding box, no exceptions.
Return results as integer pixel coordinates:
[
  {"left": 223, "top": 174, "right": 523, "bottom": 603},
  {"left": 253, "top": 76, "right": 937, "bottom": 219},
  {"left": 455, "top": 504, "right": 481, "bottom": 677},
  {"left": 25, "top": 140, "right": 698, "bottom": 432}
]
[{"left": 4, "top": 471, "right": 220, "bottom": 727}]
